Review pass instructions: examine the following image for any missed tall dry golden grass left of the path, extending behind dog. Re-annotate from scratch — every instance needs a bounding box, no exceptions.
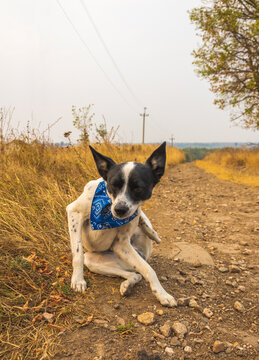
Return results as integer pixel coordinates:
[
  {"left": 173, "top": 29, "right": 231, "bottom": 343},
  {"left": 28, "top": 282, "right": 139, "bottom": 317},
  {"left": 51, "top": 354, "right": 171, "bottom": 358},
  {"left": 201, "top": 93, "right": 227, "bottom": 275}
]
[{"left": 0, "top": 141, "right": 185, "bottom": 360}]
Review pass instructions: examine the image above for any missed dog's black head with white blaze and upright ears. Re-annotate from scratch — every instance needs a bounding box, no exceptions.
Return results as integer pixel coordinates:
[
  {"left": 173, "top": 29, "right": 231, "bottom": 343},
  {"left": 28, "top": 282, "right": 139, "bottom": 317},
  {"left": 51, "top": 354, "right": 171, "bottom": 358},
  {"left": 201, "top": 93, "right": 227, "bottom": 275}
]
[{"left": 90, "top": 142, "right": 166, "bottom": 219}]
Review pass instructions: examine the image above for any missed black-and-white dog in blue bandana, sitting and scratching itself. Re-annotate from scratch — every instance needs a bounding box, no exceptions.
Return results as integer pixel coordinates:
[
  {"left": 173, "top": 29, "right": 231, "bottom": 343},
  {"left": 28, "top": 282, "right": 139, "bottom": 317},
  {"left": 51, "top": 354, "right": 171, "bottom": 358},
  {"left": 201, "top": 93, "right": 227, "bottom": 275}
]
[{"left": 66, "top": 142, "right": 177, "bottom": 307}]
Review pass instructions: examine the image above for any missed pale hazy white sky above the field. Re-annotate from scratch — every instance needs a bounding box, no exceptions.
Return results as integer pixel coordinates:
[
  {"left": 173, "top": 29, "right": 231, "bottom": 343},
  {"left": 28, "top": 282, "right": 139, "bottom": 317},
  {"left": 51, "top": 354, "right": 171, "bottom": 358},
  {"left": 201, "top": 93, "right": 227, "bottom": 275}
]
[{"left": 0, "top": 0, "right": 258, "bottom": 142}]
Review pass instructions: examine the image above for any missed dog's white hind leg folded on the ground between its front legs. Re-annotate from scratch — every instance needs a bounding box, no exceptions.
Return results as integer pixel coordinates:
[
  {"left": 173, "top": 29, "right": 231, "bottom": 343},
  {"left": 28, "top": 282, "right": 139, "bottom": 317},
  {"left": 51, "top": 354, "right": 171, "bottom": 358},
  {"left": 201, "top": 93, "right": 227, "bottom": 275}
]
[{"left": 84, "top": 251, "right": 142, "bottom": 295}]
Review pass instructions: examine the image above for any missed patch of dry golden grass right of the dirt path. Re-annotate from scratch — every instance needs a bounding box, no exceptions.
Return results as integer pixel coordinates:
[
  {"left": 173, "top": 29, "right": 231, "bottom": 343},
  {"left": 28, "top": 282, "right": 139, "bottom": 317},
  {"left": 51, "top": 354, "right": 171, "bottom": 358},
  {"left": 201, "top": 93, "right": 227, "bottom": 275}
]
[{"left": 196, "top": 148, "right": 259, "bottom": 186}]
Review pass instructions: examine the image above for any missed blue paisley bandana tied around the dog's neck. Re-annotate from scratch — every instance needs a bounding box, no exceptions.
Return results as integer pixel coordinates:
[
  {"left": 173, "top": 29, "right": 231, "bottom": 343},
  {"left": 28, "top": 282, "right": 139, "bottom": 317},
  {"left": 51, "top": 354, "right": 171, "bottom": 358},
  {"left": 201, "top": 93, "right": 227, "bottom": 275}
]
[{"left": 90, "top": 181, "right": 138, "bottom": 230}]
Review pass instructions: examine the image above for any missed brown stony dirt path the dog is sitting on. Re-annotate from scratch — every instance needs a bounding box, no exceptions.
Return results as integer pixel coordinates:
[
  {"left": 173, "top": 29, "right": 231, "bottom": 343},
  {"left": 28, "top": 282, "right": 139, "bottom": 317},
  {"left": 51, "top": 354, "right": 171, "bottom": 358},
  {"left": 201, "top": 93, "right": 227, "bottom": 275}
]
[{"left": 55, "top": 164, "right": 259, "bottom": 360}]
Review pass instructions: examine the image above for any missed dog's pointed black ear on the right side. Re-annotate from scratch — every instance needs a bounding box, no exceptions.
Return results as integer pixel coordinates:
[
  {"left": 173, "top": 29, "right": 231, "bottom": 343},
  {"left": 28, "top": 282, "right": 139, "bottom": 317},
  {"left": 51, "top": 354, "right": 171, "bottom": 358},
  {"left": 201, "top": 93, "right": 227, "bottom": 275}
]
[{"left": 146, "top": 141, "right": 166, "bottom": 185}]
